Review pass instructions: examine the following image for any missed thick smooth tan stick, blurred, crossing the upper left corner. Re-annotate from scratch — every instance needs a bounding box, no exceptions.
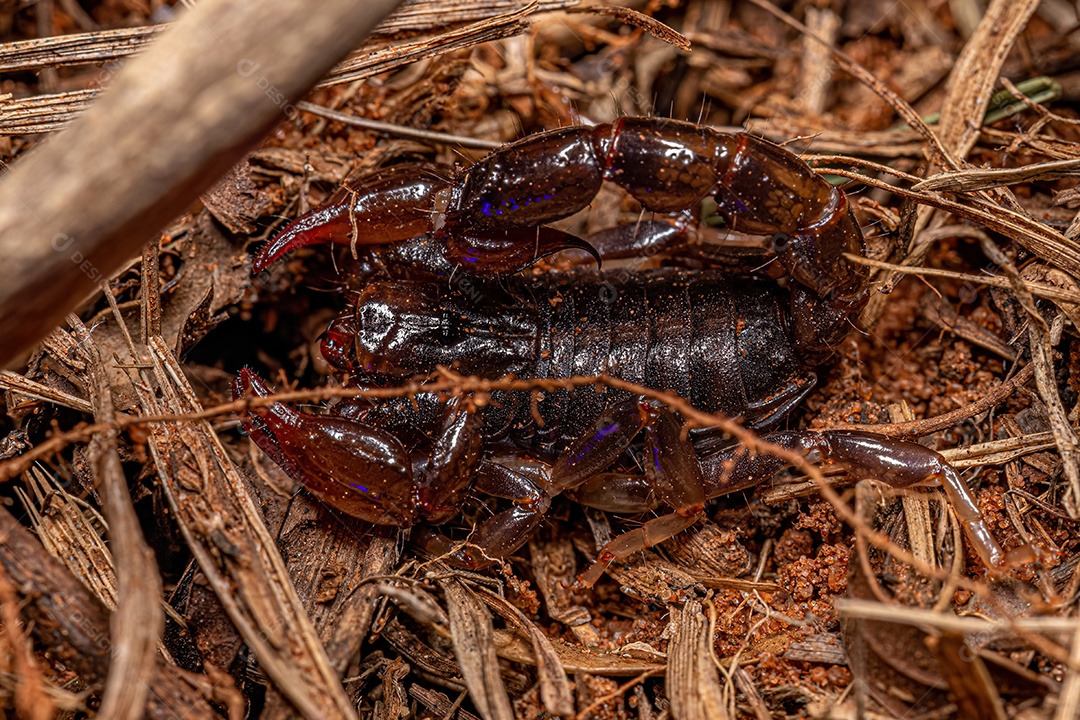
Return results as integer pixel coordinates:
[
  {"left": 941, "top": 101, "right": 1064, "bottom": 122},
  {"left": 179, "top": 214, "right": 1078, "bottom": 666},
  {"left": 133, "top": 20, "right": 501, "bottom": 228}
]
[{"left": 0, "top": 0, "right": 399, "bottom": 366}]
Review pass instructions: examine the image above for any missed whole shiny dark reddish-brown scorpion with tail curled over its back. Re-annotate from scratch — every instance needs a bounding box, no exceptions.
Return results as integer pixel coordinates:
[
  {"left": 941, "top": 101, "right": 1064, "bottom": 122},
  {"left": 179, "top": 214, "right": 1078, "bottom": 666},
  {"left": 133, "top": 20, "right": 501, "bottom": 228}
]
[{"left": 234, "top": 113, "right": 1034, "bottom": 585}]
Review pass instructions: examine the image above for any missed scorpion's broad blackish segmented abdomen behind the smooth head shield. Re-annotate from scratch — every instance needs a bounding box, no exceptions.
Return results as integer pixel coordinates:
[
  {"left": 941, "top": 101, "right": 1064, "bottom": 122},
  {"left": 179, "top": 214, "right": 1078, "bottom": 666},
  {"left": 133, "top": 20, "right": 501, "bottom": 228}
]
[{"left": 515, "top": 270, "right": 812, "bottom": 447}]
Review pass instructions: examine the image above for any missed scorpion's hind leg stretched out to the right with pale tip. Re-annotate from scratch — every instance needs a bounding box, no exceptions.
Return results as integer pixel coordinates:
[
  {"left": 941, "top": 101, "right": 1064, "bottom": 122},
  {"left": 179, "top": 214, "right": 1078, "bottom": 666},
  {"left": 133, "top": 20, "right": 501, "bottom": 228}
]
[{"left": 702, "top": 431, "right": 1039, "bottom": 570}]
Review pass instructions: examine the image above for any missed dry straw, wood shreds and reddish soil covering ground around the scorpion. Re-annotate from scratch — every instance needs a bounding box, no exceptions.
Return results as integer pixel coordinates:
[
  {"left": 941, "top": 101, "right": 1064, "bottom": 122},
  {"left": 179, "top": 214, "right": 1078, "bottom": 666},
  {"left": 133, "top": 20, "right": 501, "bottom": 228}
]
[{"left": 0, "top": 0, "right": 1080, "bottom": 720}]
